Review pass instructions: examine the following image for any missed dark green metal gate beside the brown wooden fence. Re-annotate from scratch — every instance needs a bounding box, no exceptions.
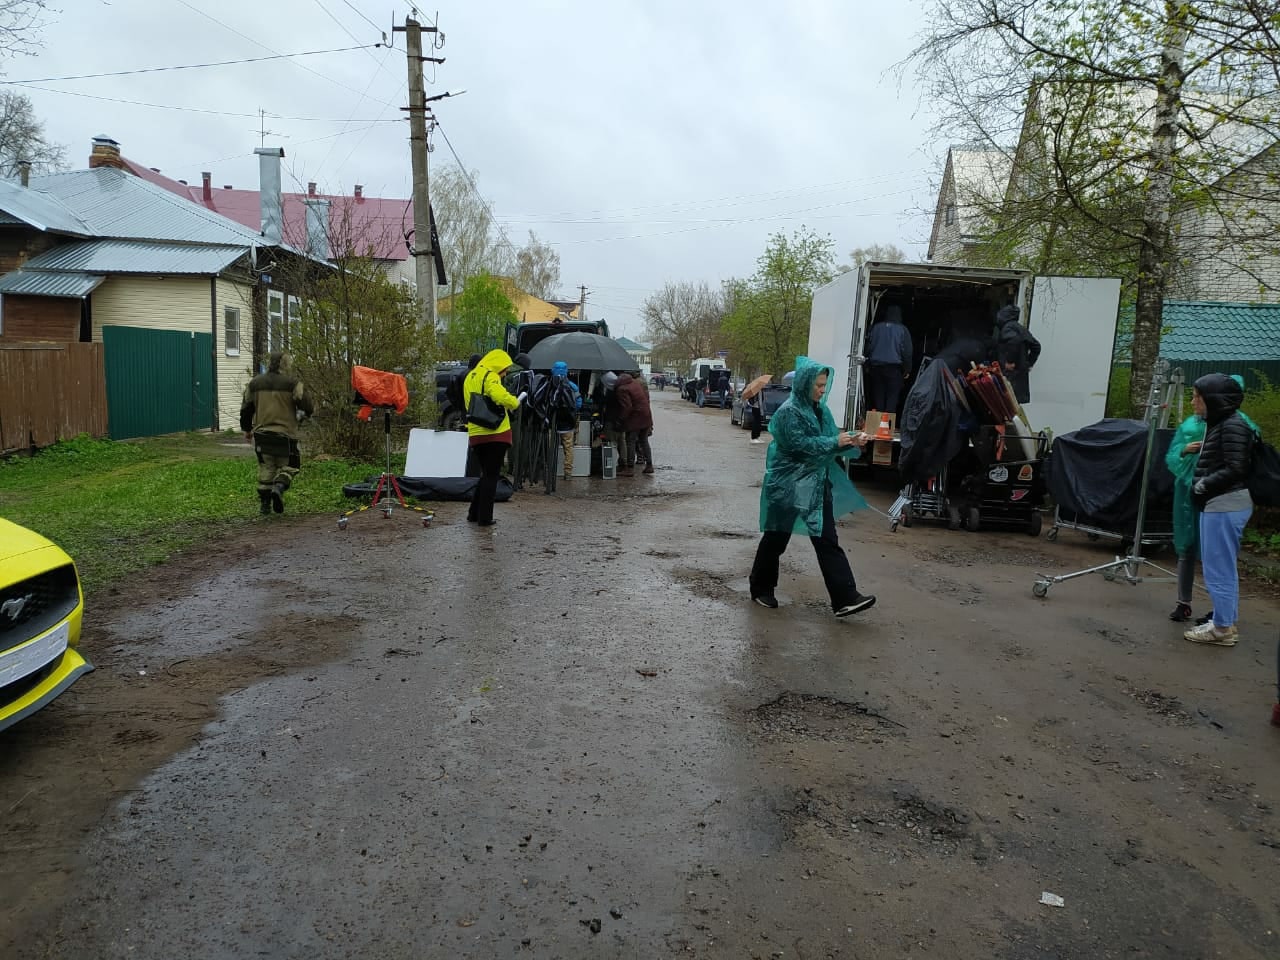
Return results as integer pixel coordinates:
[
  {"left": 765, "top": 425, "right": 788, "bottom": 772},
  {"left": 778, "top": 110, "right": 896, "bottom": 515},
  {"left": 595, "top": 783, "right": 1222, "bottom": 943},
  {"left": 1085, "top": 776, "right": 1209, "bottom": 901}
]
[{"left": 102, "top": 326, "right": 214, "bottom": 440}]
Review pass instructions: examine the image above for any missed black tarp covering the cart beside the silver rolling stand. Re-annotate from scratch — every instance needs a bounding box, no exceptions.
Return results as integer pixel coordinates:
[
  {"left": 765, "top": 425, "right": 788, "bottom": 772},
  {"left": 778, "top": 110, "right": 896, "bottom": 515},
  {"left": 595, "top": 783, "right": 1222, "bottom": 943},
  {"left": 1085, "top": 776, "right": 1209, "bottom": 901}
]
[{"left": 1044, "top": 420, "right": 1174, "bottom": 532}]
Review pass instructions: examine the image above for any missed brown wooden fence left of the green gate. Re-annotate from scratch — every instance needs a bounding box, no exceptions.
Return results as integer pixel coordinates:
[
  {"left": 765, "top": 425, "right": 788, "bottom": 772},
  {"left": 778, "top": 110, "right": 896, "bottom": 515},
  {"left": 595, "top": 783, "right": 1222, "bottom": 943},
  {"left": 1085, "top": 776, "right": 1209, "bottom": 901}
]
[{"left": 0, "top": 342, "right": 106, "bottom": 453}]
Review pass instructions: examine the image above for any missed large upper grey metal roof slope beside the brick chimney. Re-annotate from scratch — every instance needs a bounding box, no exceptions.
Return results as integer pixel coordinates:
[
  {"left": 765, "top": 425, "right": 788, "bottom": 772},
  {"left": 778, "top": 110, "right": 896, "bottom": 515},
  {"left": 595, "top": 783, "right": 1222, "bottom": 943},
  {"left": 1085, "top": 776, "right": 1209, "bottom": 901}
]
[{"left": 26, "top": 166, "right": 270, "bottom": 247}]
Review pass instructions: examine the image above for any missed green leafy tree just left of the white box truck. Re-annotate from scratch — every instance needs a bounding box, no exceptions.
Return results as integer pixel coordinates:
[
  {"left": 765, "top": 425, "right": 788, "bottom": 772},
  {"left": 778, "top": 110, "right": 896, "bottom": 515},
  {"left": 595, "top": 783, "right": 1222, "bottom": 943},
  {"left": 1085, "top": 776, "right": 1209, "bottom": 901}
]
[{"left": 724, "top": 227, "right": 836, "bottom": 375}]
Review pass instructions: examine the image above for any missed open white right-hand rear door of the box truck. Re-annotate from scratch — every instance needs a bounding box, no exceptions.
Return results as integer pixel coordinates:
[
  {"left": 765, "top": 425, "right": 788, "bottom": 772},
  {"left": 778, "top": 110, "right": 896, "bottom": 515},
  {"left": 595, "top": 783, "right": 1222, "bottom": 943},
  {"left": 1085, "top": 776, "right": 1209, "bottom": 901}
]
[{"left": 1024, "top": 276, "right": 1120, "bottom": 436}]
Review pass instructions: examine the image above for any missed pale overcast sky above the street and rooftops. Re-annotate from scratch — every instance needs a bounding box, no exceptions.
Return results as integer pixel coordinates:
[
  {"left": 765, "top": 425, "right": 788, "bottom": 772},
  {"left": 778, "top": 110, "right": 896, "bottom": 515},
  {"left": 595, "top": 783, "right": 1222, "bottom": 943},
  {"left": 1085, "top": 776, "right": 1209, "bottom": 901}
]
[{"left": 5, "top": 0, "right": 945, "bottom": 339}]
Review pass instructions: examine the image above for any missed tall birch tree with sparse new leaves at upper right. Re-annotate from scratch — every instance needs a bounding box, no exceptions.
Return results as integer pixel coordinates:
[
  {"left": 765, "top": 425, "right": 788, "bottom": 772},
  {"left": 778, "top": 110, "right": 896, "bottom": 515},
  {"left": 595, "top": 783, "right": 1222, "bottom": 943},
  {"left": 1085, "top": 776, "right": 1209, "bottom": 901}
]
[{"left": 911, "top": 0, "right": 1280, "bottom": 410}]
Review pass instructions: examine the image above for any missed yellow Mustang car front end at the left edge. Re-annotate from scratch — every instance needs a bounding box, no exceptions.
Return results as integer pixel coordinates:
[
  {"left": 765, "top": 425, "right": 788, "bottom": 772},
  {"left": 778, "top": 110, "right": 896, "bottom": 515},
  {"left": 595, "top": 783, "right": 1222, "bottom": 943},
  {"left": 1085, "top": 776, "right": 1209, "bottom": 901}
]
[{"left": 0, "top": 518, "right": 93, "bottom": 730}]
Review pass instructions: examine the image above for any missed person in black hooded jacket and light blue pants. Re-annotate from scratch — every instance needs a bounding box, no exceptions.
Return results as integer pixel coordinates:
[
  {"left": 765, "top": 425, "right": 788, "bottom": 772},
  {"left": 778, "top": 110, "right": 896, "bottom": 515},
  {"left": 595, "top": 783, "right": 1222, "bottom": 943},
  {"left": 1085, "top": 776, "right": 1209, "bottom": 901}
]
[{"left": 1183, "top": 374, "right": 1254, "bottom": 646}]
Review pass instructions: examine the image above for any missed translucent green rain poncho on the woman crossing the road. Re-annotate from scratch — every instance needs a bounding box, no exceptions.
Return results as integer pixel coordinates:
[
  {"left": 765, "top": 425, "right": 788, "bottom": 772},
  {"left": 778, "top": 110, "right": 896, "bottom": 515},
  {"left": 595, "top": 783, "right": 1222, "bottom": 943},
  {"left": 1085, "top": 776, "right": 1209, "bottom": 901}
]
[{"left": 760, "top": 357, "right": 867, "bottom": 536}]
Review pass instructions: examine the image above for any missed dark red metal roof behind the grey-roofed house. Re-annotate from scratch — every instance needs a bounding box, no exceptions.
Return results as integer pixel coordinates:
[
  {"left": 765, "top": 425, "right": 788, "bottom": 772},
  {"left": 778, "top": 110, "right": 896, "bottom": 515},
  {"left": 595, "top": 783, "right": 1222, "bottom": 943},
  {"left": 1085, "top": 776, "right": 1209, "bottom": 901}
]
[{"left": 122, "top": 157, "right": 413, "bottom": 260}]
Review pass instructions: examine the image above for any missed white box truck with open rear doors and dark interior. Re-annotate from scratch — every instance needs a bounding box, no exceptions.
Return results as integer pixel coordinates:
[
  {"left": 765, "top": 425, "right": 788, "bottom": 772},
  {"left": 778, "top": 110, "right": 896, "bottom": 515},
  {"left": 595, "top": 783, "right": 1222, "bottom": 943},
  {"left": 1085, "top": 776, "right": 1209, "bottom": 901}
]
[{"left": 809, "top": 261, "right": 1120, "bottom": 435}]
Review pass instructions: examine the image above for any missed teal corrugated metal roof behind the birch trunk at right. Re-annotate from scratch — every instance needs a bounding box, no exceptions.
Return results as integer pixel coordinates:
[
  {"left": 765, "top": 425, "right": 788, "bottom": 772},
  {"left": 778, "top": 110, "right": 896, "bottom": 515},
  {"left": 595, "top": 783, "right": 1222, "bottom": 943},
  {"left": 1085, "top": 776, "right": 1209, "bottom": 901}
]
[{"left": 1116, "top": 300, "right": 1280, "bottom": 364}]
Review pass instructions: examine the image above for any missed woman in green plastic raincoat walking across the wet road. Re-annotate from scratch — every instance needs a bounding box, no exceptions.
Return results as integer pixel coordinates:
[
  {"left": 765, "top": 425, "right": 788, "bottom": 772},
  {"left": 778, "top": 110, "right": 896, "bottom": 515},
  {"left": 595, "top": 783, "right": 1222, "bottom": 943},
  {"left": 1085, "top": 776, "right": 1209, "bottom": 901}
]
[{"left": 750, "top": 357, "right": 876, "bottom": 617}]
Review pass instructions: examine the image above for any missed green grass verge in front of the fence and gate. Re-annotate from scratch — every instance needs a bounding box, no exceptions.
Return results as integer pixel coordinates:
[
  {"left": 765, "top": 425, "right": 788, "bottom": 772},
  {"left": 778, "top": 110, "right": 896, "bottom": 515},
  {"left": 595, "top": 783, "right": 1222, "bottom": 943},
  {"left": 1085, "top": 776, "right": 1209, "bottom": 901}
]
[{"left": 0, "top": 434, "right": 379, "bottom": 593}]
